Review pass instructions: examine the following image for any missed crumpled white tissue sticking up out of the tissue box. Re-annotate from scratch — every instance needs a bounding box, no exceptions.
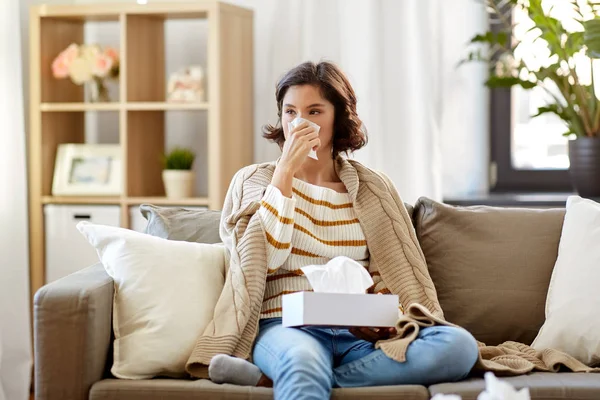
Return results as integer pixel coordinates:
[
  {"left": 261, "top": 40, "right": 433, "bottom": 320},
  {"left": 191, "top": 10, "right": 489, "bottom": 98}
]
[{"left": 302, "top": 256, "right": 373, "bottom": 294}]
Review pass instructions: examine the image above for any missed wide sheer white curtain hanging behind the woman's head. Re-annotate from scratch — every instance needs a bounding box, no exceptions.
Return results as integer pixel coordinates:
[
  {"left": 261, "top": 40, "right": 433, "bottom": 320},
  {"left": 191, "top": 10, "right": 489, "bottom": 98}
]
[{"left": 233, "top": 0, "right": 489, "bottom": 202}]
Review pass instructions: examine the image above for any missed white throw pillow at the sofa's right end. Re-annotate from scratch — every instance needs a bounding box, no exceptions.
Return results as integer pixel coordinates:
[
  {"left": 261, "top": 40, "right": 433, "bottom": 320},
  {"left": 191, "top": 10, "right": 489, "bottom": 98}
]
[{"left": 532, "top": 196, "right": 600, "bottom": 365}]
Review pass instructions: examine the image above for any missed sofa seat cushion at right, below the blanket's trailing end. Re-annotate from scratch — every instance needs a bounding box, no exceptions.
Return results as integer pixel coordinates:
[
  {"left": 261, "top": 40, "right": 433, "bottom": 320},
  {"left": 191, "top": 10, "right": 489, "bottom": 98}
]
[{"left": 429, "top": 372, "right": 600, "bottom": 400}]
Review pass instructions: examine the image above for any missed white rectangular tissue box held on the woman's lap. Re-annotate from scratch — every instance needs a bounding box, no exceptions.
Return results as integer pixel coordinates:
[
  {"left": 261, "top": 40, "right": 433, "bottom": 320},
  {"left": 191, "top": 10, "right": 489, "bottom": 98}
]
[{"left": 281, "top": 292, "right": 399, "bottom": 328}]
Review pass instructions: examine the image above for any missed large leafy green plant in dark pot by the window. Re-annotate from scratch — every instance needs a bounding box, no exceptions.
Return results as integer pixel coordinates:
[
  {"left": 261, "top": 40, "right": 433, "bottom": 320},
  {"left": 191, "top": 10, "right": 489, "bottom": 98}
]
[{"left": 462, "top": 0, "right": 600, "bottom": 197}]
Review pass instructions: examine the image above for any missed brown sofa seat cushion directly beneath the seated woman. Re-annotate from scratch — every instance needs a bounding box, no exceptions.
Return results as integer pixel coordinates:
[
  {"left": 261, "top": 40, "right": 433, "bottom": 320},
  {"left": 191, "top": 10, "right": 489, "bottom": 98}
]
[{"left": 90, "top": 379, "right": 429, "bottom": 400}]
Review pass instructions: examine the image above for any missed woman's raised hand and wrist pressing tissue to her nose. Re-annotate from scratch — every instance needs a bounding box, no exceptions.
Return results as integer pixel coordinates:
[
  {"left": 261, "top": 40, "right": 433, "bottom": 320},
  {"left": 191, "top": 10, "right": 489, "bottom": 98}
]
[{"left": 271, "top": 122, "right": 321, "bottom": 197}]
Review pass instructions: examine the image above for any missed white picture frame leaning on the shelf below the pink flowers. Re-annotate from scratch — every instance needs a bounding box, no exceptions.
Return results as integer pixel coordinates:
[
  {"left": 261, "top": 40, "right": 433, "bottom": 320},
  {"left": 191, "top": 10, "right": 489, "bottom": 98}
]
[{"left": 52, "top": 143, "right": 123, "bottom": 196}]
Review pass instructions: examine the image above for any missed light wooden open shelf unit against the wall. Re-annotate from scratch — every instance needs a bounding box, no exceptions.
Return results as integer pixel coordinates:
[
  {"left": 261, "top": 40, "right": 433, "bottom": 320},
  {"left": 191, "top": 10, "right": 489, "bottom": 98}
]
[{"left": 28, "top": 0, "right": 253, "bottom": 295}]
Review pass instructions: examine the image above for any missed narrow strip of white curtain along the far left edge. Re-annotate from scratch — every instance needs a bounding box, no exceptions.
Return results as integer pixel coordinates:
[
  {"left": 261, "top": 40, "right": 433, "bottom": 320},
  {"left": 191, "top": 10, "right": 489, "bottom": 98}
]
[{"left": 0, "top": 0, "right": 31, "bottom": 400}]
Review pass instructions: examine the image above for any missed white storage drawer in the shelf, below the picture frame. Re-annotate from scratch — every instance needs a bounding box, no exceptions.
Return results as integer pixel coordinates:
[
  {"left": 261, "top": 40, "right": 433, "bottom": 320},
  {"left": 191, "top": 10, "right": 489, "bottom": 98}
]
[{"left": 44, "top": 204, "right": 121, "bottom": 283}]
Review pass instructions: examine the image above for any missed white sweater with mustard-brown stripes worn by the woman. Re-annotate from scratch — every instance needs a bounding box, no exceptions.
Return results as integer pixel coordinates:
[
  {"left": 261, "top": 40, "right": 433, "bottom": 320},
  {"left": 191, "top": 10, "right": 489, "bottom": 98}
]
[{"left": 258, "top": 178, "right": 389, "bottom": 318}]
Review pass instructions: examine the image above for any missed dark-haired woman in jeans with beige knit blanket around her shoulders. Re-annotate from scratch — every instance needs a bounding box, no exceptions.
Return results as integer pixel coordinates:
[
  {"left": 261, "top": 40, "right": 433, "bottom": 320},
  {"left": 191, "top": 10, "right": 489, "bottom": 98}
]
[{"left": 197, "top": 62, "right": 478, "bottom": 399}]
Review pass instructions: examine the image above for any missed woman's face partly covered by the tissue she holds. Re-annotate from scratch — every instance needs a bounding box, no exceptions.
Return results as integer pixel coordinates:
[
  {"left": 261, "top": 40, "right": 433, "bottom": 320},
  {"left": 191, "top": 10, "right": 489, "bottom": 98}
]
[{"left": 281, "top": 85, "right": 335, "bottom": 152}]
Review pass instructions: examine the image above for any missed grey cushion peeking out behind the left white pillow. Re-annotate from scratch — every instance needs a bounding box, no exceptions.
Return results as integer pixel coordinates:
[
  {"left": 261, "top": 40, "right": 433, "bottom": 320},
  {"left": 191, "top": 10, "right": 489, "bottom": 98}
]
[{"left": 140, "top": 204, "right": 221, "bottom": 243}]
